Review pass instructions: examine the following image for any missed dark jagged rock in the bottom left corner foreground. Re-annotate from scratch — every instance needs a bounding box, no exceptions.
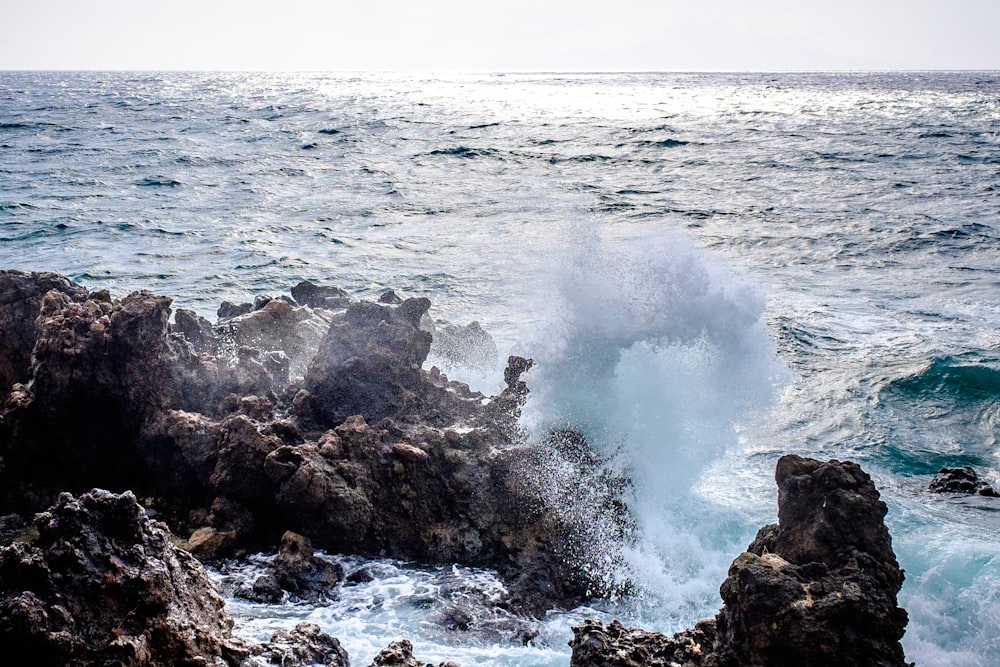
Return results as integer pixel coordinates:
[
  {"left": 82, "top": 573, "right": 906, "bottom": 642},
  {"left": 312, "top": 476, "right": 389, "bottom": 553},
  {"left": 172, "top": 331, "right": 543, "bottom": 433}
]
[{"left": 0, "top": 490, "right": 247, "bottom": 667}]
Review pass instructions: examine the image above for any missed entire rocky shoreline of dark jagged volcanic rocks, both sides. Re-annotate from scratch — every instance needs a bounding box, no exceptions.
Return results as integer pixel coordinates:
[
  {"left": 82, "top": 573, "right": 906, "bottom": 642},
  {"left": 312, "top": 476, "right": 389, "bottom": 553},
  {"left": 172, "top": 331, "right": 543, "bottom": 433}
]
[{"left": 0, "top": 271, "right": 906, "bottom": 667}]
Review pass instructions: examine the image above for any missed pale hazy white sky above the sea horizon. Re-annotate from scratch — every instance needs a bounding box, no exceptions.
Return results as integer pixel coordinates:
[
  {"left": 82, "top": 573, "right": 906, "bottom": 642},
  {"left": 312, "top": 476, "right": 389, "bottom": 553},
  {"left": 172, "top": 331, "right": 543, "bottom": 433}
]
[{"left": 0, "top": 0, "right": 1000, "bottom": 71}]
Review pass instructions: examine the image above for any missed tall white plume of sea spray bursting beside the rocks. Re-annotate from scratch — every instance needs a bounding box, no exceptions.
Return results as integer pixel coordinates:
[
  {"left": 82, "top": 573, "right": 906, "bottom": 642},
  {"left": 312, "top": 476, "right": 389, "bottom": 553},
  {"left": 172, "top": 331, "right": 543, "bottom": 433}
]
[{"left": 525, "top": 227, "right": 786, "bottom": 627}]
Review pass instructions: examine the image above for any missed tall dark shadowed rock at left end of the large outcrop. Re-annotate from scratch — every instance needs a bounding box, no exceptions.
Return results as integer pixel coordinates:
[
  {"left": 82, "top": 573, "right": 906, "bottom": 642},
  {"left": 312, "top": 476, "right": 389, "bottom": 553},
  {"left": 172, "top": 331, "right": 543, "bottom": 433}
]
[{"left": 0, "top": 290, "right": 213, "bottom": 511}]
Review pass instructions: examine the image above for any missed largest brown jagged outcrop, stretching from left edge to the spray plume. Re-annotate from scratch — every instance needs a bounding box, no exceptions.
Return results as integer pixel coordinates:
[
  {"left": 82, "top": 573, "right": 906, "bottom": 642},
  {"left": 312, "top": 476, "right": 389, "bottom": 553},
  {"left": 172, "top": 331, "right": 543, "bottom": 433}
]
[{"left": 0, "top": 272, "right": 623, "bottom": 613}]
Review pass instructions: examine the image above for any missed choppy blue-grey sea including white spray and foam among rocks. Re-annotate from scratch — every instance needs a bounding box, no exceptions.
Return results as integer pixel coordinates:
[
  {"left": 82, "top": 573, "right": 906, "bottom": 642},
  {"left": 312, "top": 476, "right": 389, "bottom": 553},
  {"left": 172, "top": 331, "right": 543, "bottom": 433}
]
[{"left": 0, "top": 72, "right": 1000, "bottom": 666}]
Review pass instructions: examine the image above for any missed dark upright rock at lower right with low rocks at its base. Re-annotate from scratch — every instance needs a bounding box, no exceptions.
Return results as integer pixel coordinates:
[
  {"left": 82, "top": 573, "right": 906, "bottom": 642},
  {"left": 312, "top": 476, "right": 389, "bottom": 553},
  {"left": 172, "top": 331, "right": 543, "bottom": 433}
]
[{"left": 572, "top": 455, "right": 907, "bottom": 667}]
